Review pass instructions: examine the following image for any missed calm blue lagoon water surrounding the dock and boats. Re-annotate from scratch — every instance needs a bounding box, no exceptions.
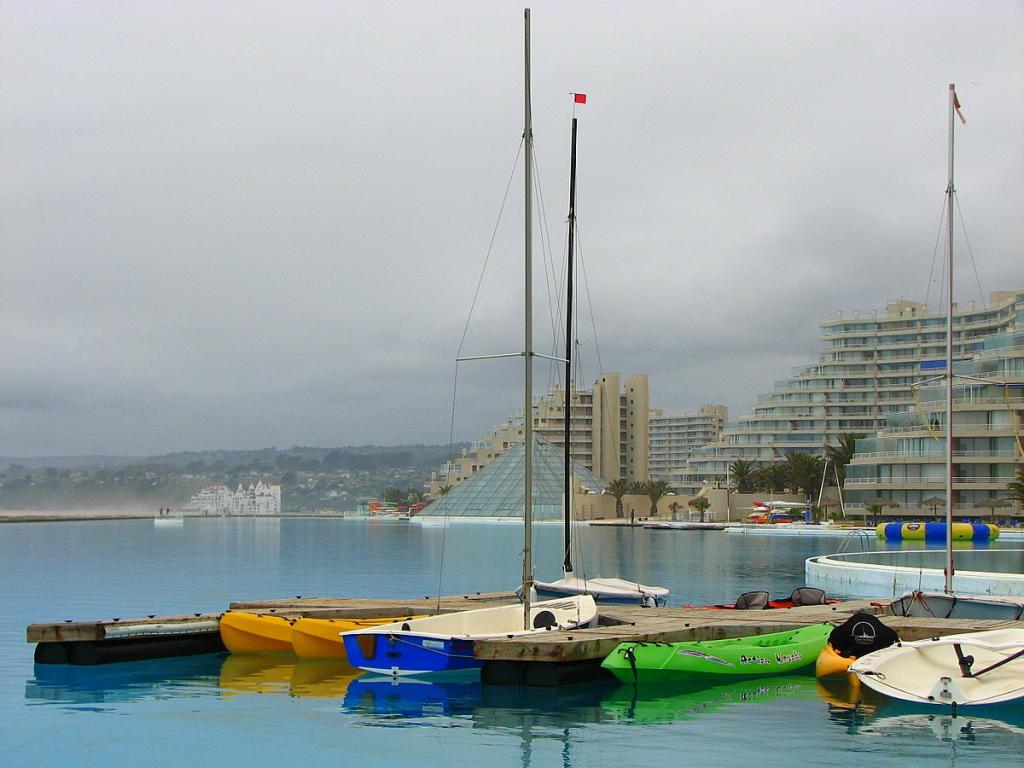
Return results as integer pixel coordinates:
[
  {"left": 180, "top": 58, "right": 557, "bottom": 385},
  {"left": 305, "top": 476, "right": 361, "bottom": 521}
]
[{"left": 0, "top": 519, "right": 1024, "bottom": 768}]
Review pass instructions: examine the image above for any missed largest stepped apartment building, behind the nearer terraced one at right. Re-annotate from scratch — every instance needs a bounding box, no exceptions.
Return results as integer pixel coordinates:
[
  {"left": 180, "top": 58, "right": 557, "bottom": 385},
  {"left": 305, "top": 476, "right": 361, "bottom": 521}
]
[{"left": 681, "top": 291, "right": 1024, "bottom": 493}]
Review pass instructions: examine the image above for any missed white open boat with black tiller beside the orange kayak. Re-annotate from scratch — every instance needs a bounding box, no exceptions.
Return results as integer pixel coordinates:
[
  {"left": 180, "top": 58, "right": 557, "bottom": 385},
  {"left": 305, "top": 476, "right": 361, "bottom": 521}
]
[{"left": 850, "top": 629, "right": 1024, "bottom": 708}]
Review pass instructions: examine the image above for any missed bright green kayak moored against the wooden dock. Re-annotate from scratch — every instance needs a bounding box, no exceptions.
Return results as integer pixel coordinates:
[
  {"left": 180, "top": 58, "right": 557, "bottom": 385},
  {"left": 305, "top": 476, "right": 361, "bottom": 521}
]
[{"left": 601, "top": 624, "right": 834, "bottom": 683}]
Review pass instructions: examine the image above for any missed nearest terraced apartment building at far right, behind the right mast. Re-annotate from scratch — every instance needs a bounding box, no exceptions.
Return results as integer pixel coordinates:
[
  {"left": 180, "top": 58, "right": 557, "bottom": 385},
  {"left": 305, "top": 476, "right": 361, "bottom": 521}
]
[{"left": 846, "top": 323, "right": 1024, "bottom": 517}]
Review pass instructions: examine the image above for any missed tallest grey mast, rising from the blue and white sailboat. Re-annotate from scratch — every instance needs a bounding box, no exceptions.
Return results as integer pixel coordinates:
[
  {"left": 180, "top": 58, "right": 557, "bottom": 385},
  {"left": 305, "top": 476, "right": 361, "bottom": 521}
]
[{"left": 522, "top": 8, "right": 534, "bottom": 630}]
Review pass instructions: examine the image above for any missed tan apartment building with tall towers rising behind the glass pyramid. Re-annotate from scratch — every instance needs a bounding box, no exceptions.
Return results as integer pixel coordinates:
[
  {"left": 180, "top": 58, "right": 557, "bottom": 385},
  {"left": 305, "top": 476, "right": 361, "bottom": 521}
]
[{"left": 428, "top": 373, "right": 650, "bottom": 498}]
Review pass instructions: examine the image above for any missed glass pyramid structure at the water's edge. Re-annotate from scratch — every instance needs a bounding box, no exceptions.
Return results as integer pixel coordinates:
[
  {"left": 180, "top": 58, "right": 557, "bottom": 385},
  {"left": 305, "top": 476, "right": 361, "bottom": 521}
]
[{"left": 417, "top": 436, "right": 607, "bottom": 520}]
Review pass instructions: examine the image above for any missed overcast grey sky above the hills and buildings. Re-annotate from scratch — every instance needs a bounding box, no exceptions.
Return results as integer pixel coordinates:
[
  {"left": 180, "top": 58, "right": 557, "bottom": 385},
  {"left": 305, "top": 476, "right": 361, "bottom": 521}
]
[{"left": 0, "top": 0, "right": 1024, "bottom": 456}]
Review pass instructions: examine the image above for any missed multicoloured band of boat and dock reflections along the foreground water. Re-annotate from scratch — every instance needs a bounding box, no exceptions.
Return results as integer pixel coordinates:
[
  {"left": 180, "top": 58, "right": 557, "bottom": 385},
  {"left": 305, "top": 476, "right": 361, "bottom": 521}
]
[{"left": 25, "top": 654, "right": 1024, "bottom": 768}]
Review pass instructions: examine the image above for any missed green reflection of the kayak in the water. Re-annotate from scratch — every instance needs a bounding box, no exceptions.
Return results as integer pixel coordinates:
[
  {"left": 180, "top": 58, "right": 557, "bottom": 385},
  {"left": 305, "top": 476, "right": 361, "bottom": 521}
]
[{"left": 602, "top": 675, "right": 818, "bottom": 724}]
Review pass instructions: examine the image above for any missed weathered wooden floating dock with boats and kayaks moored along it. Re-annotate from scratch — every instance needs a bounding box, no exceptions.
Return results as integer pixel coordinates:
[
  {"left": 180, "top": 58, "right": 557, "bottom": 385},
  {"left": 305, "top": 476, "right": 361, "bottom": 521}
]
[{"left": 26, "top": 592, "right": 1024, "bottom": 686}]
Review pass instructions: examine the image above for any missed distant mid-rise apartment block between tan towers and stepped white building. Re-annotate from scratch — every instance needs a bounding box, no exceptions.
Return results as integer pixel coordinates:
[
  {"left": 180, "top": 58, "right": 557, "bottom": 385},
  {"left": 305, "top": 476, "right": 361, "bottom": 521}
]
[{"left": 650, "top": 406, "right": 729, "bottom": 485}]
